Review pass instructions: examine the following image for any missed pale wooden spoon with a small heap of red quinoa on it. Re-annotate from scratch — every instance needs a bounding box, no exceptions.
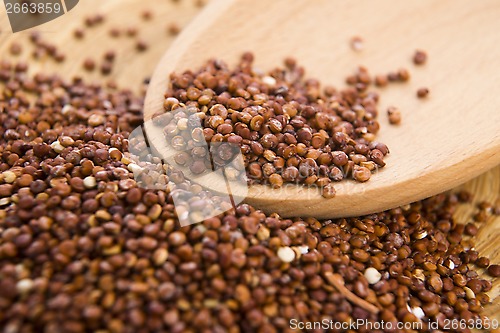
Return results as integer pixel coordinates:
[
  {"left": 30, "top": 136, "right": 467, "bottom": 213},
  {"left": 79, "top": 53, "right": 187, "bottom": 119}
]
[{"left": 145, "top": 0, "right": 500, "bottom": 218}]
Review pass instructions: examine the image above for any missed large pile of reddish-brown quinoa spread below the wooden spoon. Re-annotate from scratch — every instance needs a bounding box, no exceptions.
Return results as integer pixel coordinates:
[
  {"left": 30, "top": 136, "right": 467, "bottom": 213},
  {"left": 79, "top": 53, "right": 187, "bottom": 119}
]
[{"left": 0, "top": 60, "right": 500, "bottom": 333}]
